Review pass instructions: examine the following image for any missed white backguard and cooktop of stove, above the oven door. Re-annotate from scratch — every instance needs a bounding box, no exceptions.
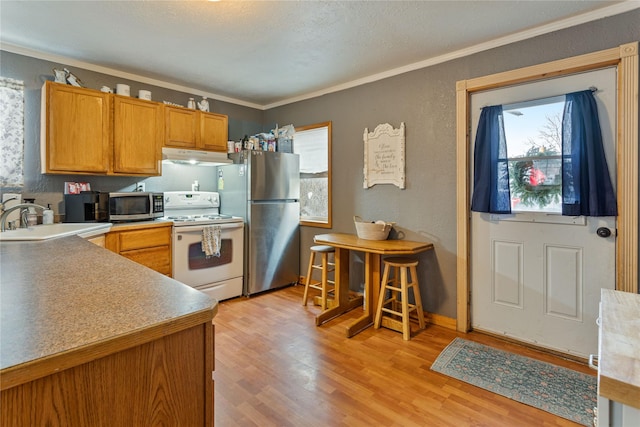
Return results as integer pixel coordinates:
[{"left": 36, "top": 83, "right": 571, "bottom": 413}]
[{"left": 163, "top": 191, "right": 244, "bottom": 227}]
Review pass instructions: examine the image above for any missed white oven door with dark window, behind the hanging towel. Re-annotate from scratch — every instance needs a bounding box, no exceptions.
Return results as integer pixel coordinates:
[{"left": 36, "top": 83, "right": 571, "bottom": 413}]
[{"left": 173, "top": 222, "right": 244, "bottom": 288}]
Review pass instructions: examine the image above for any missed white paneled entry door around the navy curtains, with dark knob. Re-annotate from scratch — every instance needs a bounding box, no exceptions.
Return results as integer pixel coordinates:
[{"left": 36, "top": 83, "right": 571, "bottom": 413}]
[{"left": 471, "top": 68, "right": 616, "bottom": 358}]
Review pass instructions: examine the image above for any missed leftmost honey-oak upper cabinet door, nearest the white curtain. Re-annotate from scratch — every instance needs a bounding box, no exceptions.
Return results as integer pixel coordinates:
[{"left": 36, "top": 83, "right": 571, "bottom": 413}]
[{"left": 41, "top": 81, "right": 113, "bottom": 174}]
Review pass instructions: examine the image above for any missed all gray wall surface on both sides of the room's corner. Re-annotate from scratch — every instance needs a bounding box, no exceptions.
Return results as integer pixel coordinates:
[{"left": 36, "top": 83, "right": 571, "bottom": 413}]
[{"left": 0, "top": 10, "right": 640, "bottom": 318}]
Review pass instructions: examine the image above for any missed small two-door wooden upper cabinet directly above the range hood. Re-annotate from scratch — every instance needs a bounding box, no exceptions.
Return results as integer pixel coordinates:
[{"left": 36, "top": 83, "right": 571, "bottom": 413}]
[{"left": 164, "top": 106, "right": 229, "bottom": 152}]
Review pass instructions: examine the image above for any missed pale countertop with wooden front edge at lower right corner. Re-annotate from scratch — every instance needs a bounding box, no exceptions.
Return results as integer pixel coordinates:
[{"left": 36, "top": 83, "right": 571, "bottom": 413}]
[{"left": 598, "top": 289, "right": 640, "bottom": 409}]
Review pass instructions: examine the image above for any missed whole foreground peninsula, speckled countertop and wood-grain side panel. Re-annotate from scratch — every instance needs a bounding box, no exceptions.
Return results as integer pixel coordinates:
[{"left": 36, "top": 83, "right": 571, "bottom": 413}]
[{"left": 0, "top": 236, "right": 218, "bottom": 427}]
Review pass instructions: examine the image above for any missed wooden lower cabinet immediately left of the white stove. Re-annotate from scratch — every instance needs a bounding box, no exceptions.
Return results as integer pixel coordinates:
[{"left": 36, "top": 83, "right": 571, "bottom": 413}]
[{"left": 105, "top": 223, "right": 172, "bottom": 276}]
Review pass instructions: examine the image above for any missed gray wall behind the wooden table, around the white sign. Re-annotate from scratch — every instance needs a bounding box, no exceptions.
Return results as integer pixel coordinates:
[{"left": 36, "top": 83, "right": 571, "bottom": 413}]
[{"left": 265, "top": 10, "right": 640, "bottom": 318}]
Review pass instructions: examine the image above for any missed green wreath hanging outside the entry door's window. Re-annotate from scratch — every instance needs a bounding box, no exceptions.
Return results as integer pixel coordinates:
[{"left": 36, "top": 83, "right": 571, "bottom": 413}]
[{"left": 509, "top": 160, "right": 562, "bottom": 207}]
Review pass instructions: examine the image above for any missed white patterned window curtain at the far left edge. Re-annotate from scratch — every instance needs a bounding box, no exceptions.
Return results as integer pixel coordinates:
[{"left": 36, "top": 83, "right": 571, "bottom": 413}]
[{"left": 0, "top": 76, "right": 24, "bottom": 187}]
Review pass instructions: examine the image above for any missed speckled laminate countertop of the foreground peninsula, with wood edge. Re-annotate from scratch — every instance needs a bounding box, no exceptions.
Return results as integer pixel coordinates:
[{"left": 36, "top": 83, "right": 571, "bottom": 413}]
[{"left": 0, "top": 236, "right": 218, "bottom": 389}]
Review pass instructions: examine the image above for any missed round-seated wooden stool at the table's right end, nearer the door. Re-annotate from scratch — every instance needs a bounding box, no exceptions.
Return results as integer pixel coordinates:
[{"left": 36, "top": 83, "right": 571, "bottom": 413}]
[{"left": 373, "top": 257, "right": 425, "bottom": 340}]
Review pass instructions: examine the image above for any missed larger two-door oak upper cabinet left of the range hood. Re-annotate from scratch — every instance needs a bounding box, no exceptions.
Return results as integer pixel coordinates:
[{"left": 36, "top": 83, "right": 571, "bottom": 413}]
[{"left": 40, "top": 81, "right": 164, "bottom": 176}]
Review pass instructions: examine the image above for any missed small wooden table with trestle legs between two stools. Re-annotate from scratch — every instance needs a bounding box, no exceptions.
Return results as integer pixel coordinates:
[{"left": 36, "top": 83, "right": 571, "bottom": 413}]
[{"left": 314, "top": 233, "right": 433, "bottom": 338}]
